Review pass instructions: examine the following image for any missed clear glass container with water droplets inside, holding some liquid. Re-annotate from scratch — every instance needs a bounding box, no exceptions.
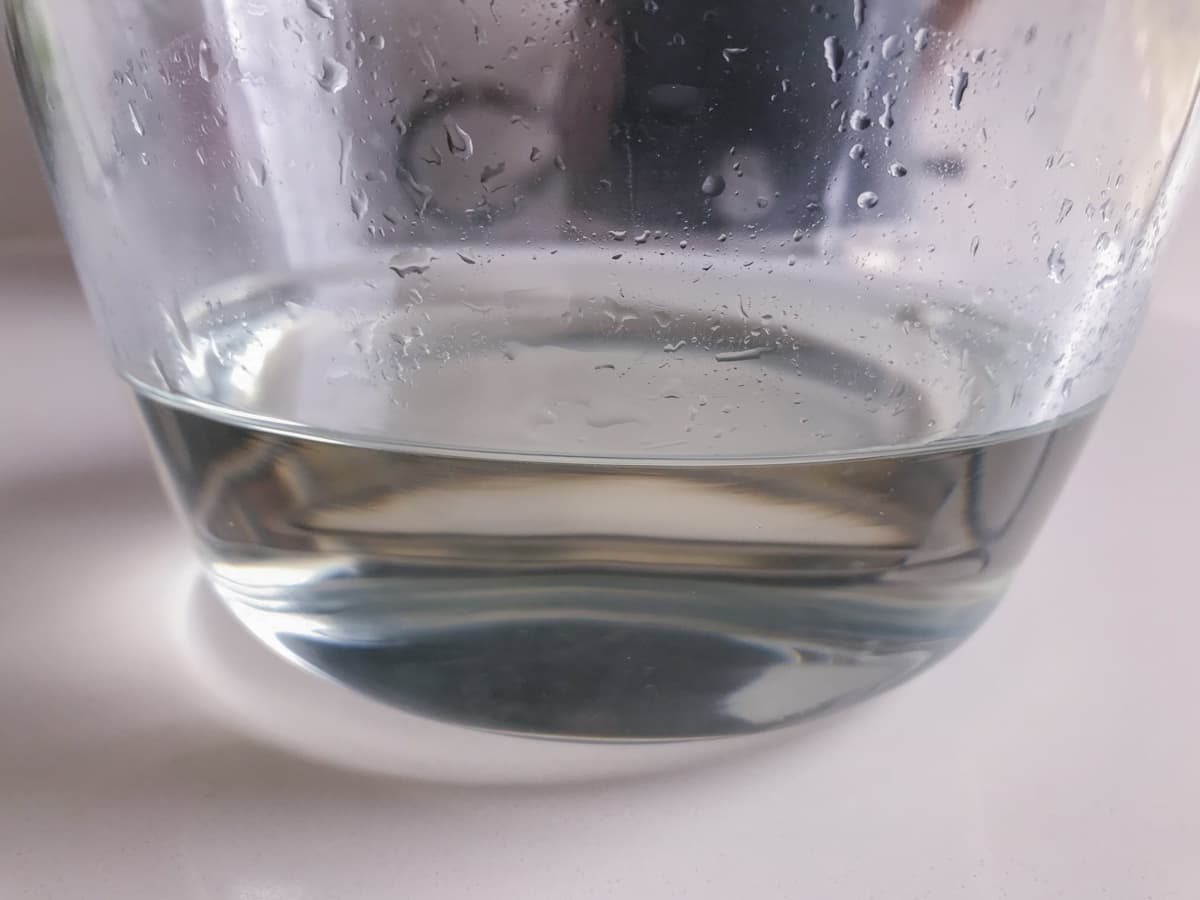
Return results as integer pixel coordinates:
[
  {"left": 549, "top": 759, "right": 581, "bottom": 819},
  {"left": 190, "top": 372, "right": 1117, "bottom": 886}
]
[{"left": 6, "top": 0, "right": 1200, "bottom": 742}]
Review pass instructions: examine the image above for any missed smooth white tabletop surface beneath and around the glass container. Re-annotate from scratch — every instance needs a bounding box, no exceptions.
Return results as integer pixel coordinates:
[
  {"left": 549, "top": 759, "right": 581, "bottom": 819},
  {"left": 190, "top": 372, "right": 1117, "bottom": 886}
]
[{"left": 0, "top": 241, "right": 1200, "bottom": 900}]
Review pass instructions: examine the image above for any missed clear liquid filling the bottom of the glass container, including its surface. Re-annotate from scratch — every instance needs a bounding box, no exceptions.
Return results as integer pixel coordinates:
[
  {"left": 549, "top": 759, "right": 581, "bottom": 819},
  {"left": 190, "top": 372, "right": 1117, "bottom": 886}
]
[{"left": 140, "top": 254, "right": 1094, "bottom": 740}]
